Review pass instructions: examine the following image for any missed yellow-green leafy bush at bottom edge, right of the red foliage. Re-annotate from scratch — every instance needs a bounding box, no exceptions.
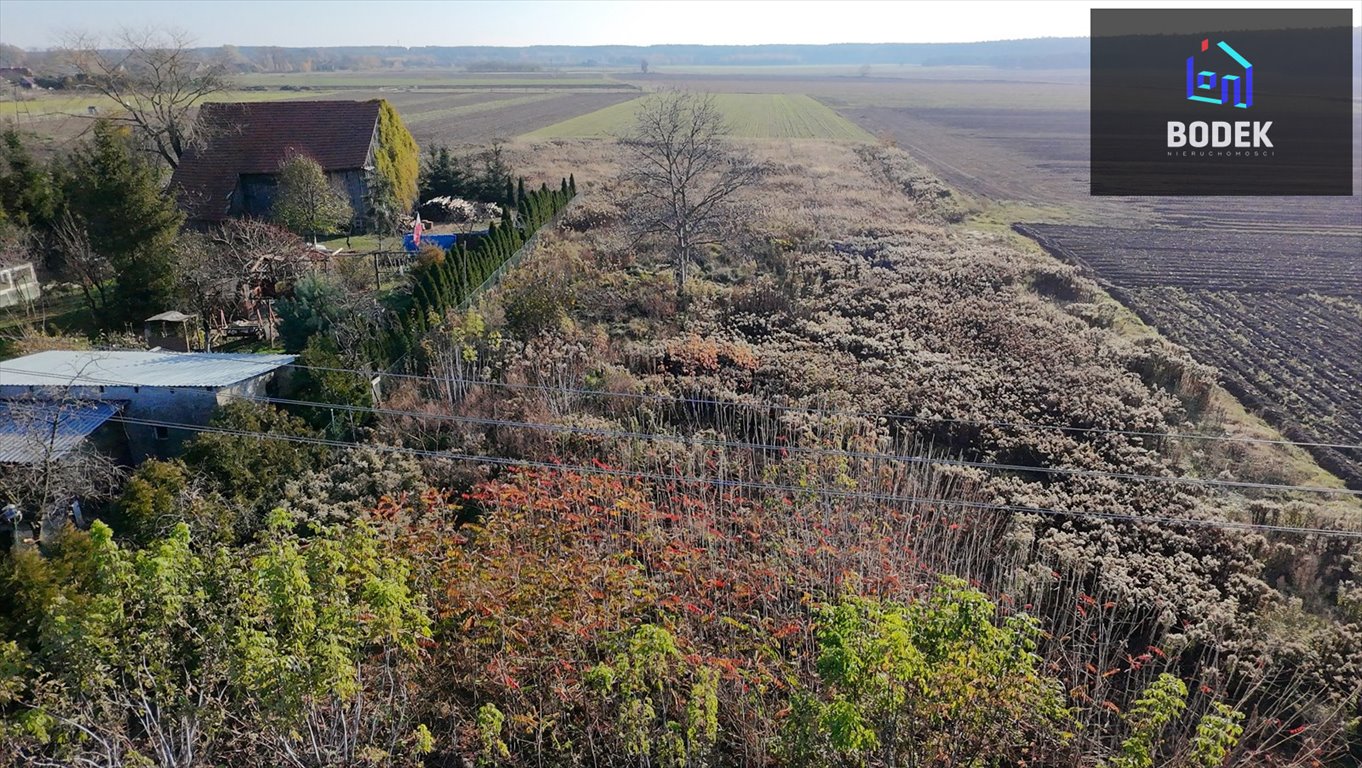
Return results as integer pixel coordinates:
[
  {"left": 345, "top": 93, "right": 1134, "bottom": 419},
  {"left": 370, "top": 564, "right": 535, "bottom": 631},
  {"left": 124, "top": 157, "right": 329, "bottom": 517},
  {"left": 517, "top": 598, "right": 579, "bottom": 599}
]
[{"left": 786, "top": 576, "right": 1071, "bottom": 765}]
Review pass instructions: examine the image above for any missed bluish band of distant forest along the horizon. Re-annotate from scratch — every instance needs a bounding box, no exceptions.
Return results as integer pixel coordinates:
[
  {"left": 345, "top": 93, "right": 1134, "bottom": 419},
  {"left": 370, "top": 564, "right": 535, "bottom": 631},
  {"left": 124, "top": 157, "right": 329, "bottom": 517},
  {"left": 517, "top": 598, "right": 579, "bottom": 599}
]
[{"left": 0, "top": 37, "right": 1088, "bottom": 72}]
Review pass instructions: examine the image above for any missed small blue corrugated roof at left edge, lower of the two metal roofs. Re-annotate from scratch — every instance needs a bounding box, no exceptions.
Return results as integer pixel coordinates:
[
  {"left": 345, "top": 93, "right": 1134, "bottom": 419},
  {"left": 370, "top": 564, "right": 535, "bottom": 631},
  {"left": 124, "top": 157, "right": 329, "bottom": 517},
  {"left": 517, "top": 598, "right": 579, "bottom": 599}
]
[{"left": 0, "top": 400, "right": 118, "bottom": 464}]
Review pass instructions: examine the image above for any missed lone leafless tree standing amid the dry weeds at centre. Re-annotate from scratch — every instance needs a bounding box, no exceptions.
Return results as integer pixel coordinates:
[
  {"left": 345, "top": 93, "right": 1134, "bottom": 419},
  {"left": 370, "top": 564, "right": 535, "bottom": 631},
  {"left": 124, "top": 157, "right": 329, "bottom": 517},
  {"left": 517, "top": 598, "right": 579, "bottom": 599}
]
[{"left": 622, "top": 90, "right": 759, "bottom": 298}]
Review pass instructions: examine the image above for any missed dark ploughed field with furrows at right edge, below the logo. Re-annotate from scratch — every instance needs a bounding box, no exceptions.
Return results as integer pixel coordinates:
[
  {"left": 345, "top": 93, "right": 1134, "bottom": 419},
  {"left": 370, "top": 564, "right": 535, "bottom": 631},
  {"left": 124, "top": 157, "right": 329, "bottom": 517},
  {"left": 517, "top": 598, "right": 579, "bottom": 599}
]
[{"left": 1016, "top": 221, "right": 1362, "bottom": 487}]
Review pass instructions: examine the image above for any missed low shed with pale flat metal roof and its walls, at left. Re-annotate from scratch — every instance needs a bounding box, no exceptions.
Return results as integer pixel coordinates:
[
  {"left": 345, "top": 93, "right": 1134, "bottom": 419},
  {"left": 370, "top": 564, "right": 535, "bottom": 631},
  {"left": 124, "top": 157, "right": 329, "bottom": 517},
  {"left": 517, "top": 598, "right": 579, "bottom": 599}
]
[{"left": 0, "top": 350, "right": 294, "bottom": 462}]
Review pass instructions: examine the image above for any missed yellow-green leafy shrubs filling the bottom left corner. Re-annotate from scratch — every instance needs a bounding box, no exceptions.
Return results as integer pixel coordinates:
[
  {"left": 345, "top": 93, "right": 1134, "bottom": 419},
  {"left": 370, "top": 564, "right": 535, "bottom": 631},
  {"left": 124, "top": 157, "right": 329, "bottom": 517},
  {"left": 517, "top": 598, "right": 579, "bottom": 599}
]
[{"left": 0, "top": 511, "right": 434, "bottom": 767}]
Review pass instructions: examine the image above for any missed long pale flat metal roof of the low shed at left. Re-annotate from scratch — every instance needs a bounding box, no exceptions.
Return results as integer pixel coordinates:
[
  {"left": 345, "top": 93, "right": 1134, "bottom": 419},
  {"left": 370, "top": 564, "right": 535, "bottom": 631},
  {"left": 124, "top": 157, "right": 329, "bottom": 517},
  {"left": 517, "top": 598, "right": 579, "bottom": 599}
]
[{"left": 0, "top": 350, "right": 297, "bottom": 387}]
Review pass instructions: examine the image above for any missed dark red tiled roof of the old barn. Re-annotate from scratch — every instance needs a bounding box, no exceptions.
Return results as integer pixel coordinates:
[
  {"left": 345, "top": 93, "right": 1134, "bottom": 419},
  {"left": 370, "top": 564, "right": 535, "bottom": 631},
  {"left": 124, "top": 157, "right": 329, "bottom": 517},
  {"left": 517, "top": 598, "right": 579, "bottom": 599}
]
[{"left": 170, "top": 101, "right": 379, "bottom": 221}]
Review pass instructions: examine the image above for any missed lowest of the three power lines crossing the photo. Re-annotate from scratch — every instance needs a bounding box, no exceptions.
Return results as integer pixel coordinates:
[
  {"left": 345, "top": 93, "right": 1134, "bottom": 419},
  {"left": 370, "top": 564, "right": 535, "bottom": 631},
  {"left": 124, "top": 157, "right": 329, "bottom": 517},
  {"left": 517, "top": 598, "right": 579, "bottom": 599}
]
[{"left": 13, "top": 403, "right": 1362, "bottom": 539}]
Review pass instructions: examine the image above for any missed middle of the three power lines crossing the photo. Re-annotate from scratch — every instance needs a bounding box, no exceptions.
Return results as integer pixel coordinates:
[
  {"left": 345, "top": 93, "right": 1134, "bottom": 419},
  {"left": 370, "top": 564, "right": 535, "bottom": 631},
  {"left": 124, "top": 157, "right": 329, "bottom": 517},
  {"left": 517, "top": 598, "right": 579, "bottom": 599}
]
[{"left": 0, "top": 366, "right": 1362, "bottom": 496}]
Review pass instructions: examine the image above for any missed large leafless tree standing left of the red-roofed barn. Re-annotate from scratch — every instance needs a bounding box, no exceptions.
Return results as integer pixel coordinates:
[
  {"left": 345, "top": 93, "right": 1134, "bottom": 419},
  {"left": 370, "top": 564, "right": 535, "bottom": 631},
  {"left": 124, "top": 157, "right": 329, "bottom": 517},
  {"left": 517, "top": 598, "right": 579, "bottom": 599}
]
[{"left": 61, "top": 30, "right": 230, "bottom": 167}]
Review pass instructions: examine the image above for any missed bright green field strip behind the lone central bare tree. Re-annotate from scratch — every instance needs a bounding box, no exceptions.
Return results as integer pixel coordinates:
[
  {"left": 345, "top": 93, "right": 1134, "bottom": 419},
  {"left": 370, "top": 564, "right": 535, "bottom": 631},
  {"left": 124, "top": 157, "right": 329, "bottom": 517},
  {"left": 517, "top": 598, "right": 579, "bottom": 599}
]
[{"left": 524, "top": 94, "right": 874, "bottom": 142}]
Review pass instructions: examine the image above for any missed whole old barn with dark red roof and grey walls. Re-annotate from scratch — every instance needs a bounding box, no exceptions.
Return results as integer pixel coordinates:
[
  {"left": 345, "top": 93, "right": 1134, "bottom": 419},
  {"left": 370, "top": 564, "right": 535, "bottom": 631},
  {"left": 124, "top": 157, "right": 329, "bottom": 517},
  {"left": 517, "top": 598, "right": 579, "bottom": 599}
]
[{"left": 170, "top": 99, "right": 389, "bottom": 226}]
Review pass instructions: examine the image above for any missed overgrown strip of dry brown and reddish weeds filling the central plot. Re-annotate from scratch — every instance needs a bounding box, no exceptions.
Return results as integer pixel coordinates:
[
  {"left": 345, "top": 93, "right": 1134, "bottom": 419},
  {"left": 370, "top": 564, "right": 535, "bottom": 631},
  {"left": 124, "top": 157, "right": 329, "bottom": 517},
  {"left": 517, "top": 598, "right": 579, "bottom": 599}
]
[{"left": 343, "top": 134, "right": 1362, "bottom": 765}]
